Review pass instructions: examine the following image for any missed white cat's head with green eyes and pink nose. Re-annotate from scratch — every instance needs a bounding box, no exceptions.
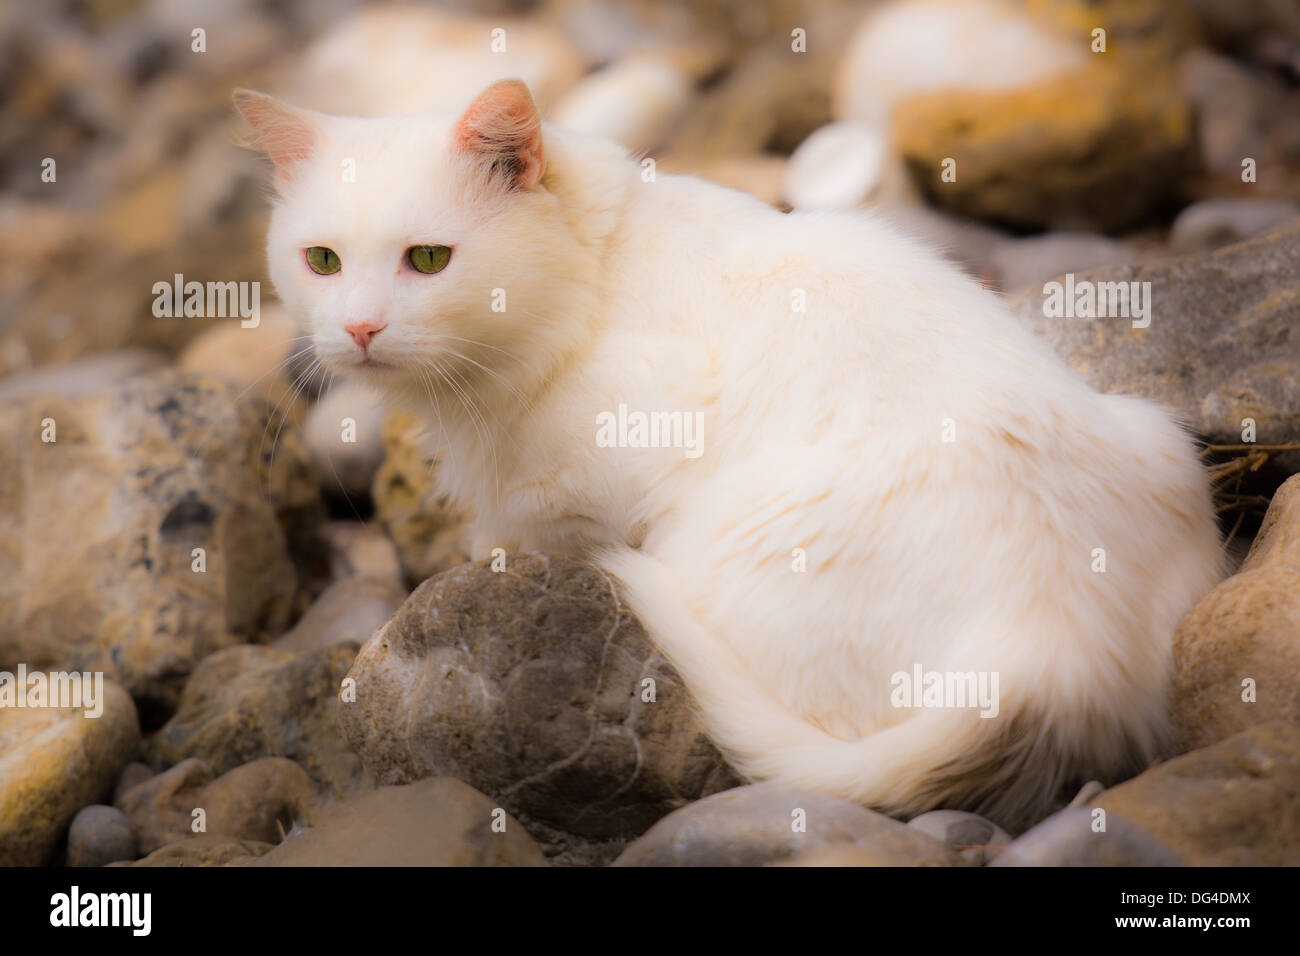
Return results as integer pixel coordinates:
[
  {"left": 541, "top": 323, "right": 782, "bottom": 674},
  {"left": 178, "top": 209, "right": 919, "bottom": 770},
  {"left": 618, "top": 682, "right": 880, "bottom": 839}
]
[{"left": 235, "top": 81, "right": 587, "bottom": 408}]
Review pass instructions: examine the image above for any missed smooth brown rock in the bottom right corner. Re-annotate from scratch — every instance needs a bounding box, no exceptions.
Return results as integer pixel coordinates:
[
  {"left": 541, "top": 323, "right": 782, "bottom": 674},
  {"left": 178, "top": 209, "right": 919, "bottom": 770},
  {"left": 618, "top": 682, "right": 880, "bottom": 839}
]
[{"left": 1092, "top": 722, "right": 1300, "bottom": 866}]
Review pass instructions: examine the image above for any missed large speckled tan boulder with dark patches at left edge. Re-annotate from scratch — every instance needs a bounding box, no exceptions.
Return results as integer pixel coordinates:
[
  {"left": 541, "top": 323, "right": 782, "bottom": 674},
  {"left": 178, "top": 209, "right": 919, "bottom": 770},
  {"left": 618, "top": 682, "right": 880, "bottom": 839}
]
[{"left": 0, "top": 372, "right": 320, "bottom": 723}]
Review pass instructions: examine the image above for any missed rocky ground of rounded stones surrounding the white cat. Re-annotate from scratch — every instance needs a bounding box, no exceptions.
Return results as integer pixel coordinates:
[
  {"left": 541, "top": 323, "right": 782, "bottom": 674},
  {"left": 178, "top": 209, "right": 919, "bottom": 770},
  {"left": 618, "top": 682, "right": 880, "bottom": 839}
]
[{"left": 0, "top": 0, "right": 1300, "bottom": 866}]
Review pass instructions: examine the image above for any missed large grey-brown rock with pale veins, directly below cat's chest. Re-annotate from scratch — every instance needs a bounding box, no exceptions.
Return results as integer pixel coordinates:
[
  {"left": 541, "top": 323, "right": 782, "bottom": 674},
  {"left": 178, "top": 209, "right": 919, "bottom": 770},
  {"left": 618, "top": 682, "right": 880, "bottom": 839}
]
[{"left": 341, "top": 554, "right": 737, "bottom": 853}]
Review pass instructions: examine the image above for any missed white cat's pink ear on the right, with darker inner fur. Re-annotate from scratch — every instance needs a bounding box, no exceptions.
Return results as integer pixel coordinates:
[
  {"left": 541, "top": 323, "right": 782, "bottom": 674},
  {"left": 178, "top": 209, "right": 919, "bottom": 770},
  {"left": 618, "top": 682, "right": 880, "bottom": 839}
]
[{"left": 454, "top": 79, "right": 543, "bottom": 189}]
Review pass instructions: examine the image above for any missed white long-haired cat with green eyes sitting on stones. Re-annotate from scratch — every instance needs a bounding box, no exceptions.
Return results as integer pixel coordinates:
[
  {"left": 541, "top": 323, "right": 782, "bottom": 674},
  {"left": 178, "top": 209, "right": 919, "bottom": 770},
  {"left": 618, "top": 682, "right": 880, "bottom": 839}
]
[{"left": 237, "top": 81, "right": 1222, "bottom": 826}]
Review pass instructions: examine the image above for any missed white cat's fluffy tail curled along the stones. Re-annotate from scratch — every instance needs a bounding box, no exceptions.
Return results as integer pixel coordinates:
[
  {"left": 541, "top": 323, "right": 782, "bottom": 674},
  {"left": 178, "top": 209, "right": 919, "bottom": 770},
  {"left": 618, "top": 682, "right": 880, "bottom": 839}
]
[{"left": 595, "top": 549, "right": 1005, "bottom": 813}]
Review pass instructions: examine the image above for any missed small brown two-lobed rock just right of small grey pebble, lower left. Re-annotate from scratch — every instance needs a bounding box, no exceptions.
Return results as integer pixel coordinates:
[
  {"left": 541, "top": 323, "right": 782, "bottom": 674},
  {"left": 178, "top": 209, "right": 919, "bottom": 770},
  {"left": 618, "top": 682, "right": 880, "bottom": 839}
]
[{"left": 122, "top": 757, "right": 316, "bottom": 855}]
